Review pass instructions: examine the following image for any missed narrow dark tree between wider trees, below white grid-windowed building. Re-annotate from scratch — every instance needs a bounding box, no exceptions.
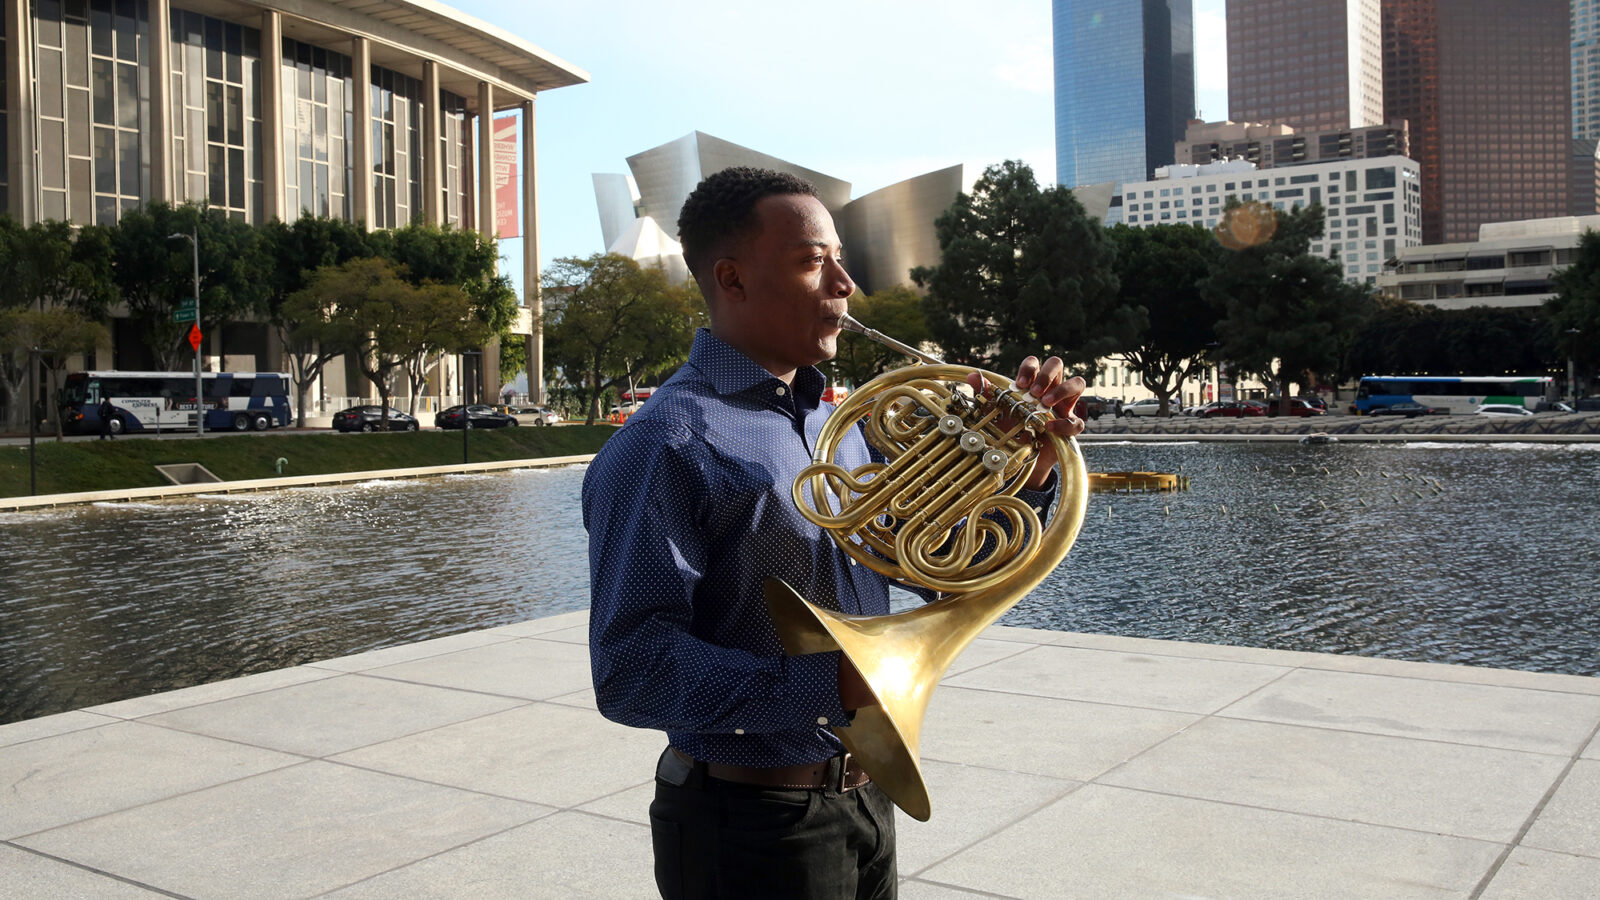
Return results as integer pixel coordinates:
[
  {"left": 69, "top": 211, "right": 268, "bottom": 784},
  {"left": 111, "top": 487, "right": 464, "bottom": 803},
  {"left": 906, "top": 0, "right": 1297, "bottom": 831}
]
[{"left": 1106, "top": 224, "right": 1224, "bottom": 416}]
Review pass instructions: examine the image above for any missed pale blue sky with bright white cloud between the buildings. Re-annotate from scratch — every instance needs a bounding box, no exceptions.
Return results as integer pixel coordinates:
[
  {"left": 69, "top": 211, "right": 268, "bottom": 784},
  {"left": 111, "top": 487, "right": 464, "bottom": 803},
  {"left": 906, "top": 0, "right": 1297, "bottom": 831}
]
[{"left": 445, "top": 0, "right": 1227, "bottom": 291}]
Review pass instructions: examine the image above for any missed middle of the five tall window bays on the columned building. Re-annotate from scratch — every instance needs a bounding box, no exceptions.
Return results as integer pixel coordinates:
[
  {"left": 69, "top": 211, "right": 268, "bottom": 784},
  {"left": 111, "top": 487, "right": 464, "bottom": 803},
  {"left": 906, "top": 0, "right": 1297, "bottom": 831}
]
[{"left": 280, "top": 38, "right": 357, "bottom": 221}]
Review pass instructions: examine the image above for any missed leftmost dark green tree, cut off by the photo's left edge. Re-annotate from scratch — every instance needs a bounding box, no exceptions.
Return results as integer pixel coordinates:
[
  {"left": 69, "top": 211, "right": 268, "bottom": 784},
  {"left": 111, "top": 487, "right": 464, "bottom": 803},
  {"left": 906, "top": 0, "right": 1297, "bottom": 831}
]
[{"left": 0, "top": 215, "right": 114, "bottom": 429}]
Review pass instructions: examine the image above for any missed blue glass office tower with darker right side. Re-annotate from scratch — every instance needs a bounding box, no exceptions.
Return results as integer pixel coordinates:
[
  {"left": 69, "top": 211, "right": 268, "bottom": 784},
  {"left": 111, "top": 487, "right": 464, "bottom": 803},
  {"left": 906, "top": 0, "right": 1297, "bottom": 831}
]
[{"left": 1053, "top": 0, "right": 1195, "bottom": 187}]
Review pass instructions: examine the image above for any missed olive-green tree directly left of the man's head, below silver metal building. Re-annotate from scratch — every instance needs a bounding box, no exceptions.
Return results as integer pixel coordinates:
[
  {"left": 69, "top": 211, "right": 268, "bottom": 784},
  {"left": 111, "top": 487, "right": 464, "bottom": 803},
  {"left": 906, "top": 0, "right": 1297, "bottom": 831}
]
[{"left": 541, "top": 253, "right": 706, "bottom": 424}]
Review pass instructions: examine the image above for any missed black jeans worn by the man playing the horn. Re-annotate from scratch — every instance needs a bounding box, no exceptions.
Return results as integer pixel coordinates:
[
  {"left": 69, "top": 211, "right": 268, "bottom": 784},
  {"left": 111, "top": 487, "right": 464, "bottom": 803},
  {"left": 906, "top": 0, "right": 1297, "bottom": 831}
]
[{"left": 650, "top": 749, "right": 896, "bottom": 900}]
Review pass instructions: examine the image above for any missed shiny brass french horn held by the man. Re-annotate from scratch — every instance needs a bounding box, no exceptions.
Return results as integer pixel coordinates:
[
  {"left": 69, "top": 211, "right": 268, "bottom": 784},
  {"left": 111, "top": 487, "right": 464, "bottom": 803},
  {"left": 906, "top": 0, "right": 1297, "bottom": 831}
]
[{"left": 765, "top": 315, "right": 1088, "bottom": 822}]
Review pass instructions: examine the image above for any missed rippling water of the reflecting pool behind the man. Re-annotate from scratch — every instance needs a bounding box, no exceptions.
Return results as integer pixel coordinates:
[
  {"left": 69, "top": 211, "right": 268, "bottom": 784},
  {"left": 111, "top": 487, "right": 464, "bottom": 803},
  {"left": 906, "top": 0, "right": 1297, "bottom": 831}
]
[{"left": 0, "top": 442, "right": 1600, "bottom": 722}]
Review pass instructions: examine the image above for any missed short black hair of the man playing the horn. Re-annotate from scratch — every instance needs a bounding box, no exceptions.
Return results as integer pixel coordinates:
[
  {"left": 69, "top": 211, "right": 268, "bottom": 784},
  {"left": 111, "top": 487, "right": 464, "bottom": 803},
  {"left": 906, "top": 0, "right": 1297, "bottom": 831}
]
[{"left": 678, "top": 165, "right": 816, "bottom": 285}]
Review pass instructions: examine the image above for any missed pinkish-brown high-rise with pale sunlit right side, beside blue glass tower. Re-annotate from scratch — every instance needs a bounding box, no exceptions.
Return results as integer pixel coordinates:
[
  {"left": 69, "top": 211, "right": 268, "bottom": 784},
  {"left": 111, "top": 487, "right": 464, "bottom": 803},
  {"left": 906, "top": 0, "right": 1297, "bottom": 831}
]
[{"left": 1227, "top": 0, "right": 1384, "bottom": 131}]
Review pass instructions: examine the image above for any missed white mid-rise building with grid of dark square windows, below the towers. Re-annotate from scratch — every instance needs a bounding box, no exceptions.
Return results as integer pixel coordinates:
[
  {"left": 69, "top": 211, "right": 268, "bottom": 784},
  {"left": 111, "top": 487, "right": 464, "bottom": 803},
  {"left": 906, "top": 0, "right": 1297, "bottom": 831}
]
[{"left": 1123, "top": 157, "right": 1422, "bottom": 283}]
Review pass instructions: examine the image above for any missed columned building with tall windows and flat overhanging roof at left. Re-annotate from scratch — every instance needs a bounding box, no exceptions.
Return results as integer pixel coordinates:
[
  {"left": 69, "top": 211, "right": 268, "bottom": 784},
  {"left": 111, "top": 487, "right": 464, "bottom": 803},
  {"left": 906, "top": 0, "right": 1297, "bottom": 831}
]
[{"left": 0, "top": 0, "right": 587, "bottom": 403}]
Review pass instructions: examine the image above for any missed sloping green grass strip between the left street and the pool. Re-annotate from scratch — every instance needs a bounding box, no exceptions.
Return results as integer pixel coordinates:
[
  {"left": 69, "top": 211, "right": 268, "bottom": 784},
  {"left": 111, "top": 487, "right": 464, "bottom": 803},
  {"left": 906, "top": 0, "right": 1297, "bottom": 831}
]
[{"left": 0, "top": 424, "right": 616, "bottom": 496}]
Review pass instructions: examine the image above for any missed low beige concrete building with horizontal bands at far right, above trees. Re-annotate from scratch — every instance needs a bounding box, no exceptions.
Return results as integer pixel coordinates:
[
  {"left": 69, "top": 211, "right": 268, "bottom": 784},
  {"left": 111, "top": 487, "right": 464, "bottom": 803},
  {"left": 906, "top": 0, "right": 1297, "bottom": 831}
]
[{"left": 1378, "top": 216, "right": 1600, "bottom": 309}]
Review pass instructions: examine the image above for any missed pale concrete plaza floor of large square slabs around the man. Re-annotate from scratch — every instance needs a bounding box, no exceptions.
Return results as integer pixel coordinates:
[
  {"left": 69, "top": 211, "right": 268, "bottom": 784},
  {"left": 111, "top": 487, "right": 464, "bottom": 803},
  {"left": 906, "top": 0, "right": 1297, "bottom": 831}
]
[{"left": 0, "top": 612, "right": 1600, "bottom": 900}]
